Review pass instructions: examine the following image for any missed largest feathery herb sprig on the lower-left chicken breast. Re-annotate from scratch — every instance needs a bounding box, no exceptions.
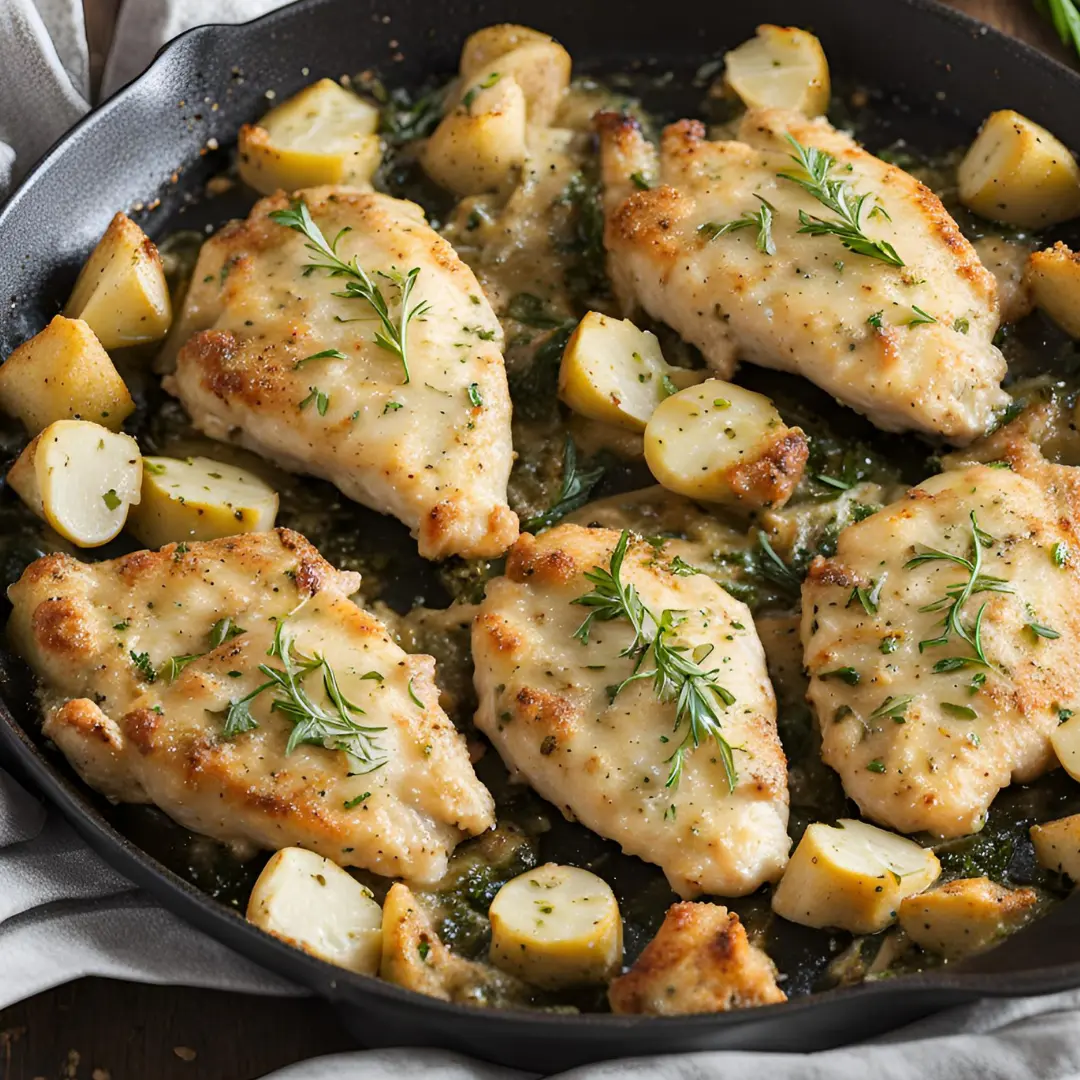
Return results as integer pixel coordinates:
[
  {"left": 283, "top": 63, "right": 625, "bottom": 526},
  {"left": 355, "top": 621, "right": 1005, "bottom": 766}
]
[{"left": 224, "top": 619, "right": 387, "bottom": 772}]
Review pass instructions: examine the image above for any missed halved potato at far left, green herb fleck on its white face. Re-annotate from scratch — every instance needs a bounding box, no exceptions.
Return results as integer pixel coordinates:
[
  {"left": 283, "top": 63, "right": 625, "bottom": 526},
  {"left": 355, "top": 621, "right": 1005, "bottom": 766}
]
[{"left": 8, "top": 420, "right": 143, "bottom": 548}]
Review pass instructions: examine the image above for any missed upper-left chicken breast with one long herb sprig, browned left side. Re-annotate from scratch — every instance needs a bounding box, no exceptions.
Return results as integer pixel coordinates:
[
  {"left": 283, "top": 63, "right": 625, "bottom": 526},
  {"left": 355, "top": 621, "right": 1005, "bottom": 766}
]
[{"left": 165, "top": 188, "right": 517, "bottom": 558}]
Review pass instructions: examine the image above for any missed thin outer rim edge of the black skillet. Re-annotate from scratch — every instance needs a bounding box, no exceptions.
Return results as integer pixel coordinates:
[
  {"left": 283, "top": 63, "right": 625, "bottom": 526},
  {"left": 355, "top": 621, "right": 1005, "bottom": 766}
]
[{"left": 0, "top": 0, "right": 1080, "bottom": 1039}]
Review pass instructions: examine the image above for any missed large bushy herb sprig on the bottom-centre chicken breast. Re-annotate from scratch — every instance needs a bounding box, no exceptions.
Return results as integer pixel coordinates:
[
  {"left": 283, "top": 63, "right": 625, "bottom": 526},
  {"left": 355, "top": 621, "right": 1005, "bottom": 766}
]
[{"left": 571, "top": 529, "right": 739, "bottom": 791}]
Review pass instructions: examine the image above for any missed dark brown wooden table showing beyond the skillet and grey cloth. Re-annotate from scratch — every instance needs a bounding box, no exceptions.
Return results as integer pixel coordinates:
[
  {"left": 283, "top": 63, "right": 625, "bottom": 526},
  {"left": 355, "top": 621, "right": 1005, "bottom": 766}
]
[{"left": 0, "top": 0, "right": 1069, "bottom": 1080}]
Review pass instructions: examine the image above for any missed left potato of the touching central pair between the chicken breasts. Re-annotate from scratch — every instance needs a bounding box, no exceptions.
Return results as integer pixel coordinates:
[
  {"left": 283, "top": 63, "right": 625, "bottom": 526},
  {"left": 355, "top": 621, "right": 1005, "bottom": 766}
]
[{"left": 558, "top": 311, "right": 703, "bottom": 432}]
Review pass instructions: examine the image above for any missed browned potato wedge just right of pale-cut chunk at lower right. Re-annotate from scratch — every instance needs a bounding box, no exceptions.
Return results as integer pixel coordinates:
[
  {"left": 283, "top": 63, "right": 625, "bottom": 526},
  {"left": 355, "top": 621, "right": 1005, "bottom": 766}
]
[{"left": 900, "top": 877, "right": 1039, "bottom": 959}]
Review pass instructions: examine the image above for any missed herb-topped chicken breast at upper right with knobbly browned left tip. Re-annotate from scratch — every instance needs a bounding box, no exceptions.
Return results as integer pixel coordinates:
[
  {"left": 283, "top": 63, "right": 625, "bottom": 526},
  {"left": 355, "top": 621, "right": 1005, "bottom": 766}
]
[{"left": 598, "top": 109, "right": 1009, "bottom": 444}]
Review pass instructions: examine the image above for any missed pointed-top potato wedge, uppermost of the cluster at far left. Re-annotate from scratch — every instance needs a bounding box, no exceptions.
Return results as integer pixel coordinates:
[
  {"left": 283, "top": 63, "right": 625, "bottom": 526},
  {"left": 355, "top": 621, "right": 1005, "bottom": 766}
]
[{"left": 64, "top": 214, "right": 173, "bottom": 349}]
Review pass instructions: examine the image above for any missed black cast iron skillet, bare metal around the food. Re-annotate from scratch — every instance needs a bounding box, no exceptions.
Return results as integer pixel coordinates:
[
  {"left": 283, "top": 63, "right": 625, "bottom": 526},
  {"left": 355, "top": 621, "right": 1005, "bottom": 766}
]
[{"left": 0, "top": 0, "right": 1080, "bottom": 1071}]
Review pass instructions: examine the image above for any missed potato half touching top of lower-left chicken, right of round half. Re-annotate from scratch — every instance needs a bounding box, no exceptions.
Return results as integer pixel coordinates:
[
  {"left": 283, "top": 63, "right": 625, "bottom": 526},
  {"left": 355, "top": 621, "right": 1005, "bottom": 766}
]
[{"left": 127, "top": 458, "right": 278, "bottom": 548}]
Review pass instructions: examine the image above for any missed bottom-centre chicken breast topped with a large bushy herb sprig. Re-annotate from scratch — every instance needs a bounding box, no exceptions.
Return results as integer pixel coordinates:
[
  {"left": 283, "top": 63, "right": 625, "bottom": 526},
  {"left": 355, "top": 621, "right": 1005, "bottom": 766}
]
[{"left": 473, "top": 525, "right": 789, "bottom": 896}]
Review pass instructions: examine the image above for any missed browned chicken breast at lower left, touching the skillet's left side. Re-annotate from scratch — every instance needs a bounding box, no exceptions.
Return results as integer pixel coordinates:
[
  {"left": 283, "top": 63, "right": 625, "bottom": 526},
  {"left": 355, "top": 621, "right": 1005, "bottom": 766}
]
[{"left": 9, "top": 529, "right": 494, "bottom": 883}]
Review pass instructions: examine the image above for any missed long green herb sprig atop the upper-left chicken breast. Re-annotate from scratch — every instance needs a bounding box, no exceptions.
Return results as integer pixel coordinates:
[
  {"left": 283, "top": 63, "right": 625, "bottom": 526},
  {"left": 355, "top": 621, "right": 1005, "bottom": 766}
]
[{"left": 270, "top": 199, "right": 431, "bottom": 382}]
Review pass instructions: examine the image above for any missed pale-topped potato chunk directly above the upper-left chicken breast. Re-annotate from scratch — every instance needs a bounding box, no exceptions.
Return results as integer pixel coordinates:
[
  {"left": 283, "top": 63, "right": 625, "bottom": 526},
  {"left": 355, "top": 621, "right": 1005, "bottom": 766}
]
[{"left": 239, "top": 79, "right": 382, "bottom": 195}]
